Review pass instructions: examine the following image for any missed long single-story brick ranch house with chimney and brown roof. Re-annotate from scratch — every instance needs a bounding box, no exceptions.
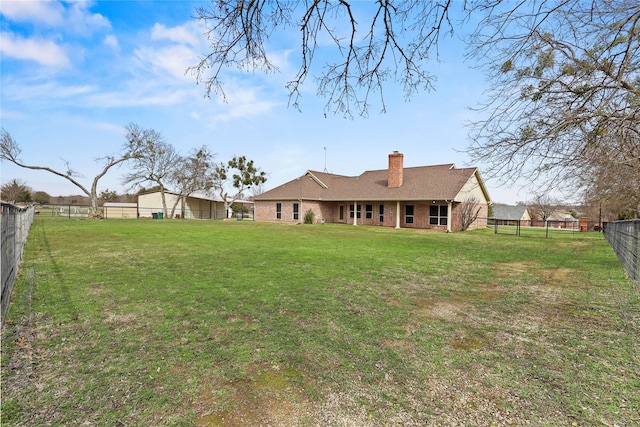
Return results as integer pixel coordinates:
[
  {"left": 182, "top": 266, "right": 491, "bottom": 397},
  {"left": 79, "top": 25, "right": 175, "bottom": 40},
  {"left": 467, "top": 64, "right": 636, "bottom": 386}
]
[{"left": 253, "top": 152, "right": 490, "bottom": 231}]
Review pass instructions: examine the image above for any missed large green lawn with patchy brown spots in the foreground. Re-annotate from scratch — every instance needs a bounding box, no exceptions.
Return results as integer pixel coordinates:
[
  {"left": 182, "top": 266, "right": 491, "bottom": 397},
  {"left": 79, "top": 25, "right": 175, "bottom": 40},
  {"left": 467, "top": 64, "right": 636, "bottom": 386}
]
[{"left": 2, "top": 217, "right": 640, "bottom": 426}]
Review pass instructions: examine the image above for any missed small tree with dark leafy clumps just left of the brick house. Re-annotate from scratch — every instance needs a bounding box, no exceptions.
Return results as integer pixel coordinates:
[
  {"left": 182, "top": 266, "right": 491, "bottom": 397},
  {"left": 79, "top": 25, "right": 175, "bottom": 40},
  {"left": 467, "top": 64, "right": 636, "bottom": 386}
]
[{"left": 212, "top": 156, "right": 267, "bottom": 217}]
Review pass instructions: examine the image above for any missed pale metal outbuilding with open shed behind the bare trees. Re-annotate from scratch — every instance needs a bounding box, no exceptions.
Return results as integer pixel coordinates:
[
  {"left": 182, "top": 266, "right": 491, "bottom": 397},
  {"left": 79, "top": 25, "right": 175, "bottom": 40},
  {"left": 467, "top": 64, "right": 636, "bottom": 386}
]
[{"left": 138, "top": 191, "right": 253, "bottom": 219}]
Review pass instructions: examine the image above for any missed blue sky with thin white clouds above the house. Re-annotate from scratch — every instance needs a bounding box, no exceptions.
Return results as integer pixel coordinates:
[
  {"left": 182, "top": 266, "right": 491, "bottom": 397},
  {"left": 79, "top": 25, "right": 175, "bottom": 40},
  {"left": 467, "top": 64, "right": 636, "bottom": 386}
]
[{"left": 0, "top": 0, "right": 532, "bottom": 203}]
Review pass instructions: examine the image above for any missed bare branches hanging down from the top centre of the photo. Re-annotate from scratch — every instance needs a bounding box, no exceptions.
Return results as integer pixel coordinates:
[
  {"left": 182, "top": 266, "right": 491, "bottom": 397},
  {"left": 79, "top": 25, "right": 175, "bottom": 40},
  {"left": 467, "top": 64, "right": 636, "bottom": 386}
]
[{"left": 187, "top": 0, "right": 458, "bottom": 117}]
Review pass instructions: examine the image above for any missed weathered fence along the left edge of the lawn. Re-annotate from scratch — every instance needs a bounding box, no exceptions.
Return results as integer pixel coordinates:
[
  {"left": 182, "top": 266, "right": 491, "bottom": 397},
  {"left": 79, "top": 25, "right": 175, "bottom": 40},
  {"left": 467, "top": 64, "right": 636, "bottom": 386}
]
[{"left": 0, "top": 202, "right": 35, "bottom": 325}]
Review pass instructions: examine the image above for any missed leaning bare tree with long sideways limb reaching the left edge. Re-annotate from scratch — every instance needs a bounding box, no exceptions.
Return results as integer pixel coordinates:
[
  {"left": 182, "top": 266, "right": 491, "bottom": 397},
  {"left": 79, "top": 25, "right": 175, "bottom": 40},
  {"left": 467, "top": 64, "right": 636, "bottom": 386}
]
[{"left": 0, "top": 125, "right": 148, "bottom": 218}]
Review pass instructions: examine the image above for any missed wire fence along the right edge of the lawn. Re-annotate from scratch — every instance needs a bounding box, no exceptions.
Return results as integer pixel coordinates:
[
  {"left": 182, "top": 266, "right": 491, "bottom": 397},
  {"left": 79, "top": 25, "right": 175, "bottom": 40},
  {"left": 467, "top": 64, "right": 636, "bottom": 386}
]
[{"left": 604, "top": 219, "right": 640, "bottom": 290}]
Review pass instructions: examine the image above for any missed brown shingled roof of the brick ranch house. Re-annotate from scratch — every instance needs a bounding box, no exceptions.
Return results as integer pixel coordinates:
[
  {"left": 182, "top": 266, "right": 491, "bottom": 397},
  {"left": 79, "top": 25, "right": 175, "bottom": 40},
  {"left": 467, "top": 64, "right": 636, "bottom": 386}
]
[{"left": 253, "top": 164, "right": 490, "bottom": 201}]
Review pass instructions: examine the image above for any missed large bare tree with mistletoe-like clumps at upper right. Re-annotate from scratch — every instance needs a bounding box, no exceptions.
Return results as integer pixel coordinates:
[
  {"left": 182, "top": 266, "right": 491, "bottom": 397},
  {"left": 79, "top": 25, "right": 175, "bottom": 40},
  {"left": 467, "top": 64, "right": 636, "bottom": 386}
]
[{"left": 468, "top": 0, "right": 640, "bottom": 193}]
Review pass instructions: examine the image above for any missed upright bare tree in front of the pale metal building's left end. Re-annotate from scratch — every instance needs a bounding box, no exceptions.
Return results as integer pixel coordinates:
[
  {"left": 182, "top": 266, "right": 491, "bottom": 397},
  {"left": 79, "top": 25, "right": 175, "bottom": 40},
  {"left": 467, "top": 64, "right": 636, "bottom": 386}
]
[{"left": 122, "top": 124, "right": 180, "bottom": 218}]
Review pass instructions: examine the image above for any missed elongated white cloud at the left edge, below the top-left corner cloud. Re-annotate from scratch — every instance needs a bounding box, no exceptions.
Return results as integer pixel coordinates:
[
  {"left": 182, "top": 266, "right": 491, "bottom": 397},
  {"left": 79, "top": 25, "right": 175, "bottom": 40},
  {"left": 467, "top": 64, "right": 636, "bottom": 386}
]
[{"left": 0, "top": 32, "right": 70, "bottom": 68}]
